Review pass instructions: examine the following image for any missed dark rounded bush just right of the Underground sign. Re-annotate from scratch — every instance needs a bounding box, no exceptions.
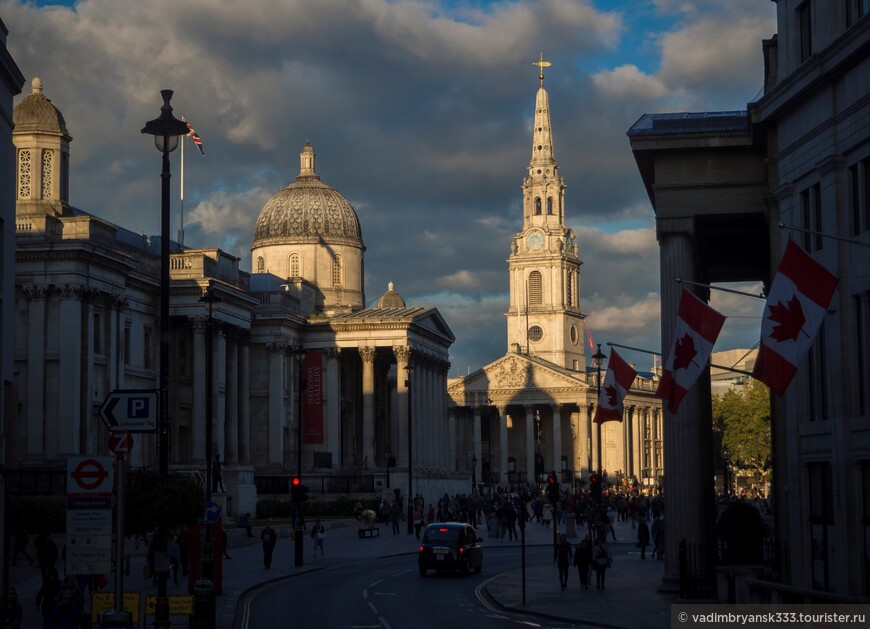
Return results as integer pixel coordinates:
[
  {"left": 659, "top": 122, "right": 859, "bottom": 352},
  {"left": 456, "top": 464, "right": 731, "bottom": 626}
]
[{"left": 125, "top": 472, "right": 205, "bottom": 536}]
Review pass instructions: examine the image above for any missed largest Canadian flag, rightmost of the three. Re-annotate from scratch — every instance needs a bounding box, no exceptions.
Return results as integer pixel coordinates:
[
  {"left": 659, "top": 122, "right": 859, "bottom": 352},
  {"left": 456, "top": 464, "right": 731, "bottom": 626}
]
[{"left": 752, "top": 240, "right": 837, "bottom": 395}]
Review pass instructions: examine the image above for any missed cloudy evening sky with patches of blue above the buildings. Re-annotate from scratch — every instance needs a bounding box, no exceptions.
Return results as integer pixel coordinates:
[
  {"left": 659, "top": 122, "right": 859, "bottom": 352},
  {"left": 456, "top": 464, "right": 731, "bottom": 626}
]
[{"left": 0, "top": 0, "right": 776, "bottom": 376}]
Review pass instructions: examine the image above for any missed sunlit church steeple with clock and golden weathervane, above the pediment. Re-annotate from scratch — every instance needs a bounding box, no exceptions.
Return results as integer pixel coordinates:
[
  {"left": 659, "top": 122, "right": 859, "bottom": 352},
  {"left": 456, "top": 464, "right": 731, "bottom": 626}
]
[{"left": 506, "top": 55, "right": 586, "bottom": 371}]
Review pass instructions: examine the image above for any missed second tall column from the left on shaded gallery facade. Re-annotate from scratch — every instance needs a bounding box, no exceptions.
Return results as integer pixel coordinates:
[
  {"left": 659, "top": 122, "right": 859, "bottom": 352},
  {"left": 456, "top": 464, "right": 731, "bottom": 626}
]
[{"left": 57, "top": 284, "right": 82, "bottom": 458}]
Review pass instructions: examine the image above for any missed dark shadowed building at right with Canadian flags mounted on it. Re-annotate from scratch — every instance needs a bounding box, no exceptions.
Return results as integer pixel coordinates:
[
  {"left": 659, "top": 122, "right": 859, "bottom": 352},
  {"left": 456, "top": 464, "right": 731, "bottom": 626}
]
[{"left": 628, "top": 0, "right": 870, "bottom": 602}]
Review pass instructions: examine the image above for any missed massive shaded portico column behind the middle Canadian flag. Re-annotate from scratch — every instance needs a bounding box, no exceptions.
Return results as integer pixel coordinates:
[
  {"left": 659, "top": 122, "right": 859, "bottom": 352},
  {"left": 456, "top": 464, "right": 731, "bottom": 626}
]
[{"left": 659, "top": 228, "right": 716, "bottom": 589}]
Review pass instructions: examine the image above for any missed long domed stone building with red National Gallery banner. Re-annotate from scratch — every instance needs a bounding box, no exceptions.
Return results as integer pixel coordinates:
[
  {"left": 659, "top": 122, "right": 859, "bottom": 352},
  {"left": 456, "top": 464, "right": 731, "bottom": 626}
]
[{"left": 6, "top": 79, "right": 468, "bottom": 516}]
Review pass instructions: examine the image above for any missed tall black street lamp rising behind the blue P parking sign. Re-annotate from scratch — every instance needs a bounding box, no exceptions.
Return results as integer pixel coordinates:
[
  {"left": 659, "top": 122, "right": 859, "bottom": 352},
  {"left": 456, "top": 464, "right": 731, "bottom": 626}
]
[{"left": 142, "top": 90, "right": 187, "bottom": 629}]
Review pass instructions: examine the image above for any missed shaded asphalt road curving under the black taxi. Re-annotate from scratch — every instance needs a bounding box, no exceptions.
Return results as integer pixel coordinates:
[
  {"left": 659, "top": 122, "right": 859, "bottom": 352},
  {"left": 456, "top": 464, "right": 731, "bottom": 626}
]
[{"left": 235, "top": 547, "right": 577, "bottom": 629}]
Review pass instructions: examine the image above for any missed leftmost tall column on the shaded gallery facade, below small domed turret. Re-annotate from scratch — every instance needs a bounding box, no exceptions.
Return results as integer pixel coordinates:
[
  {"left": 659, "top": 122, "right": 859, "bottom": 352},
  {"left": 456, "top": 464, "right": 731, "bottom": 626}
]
[{"left": 24, "top": 284, "right": 46, "bottom": 460}]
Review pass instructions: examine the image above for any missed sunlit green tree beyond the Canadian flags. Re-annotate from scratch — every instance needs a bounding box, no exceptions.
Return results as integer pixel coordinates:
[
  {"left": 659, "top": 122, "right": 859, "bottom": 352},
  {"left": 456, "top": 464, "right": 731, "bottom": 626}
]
[{"left": 713, "top": 380, "right": 772, "bottom": 484}]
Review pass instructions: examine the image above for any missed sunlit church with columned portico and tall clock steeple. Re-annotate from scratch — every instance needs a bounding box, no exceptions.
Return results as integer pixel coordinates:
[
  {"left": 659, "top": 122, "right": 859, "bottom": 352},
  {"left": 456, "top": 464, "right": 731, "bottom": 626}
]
[{"left": 448, "top": 66, "right": 664, "bottom": 490}]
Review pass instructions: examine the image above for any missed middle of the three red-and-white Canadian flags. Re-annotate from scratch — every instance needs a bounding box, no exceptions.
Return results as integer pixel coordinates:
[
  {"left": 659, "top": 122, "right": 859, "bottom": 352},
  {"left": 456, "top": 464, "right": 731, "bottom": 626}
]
[{"left": 656, "top": 288, "right": 725, "bottom": 413}]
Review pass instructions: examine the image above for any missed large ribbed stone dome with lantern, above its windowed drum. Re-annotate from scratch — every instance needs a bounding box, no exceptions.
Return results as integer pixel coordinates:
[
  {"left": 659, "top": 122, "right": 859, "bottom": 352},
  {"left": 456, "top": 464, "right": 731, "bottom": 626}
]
[{"left": 253, "top": 142, "right": 362, "bottom": 247}]
